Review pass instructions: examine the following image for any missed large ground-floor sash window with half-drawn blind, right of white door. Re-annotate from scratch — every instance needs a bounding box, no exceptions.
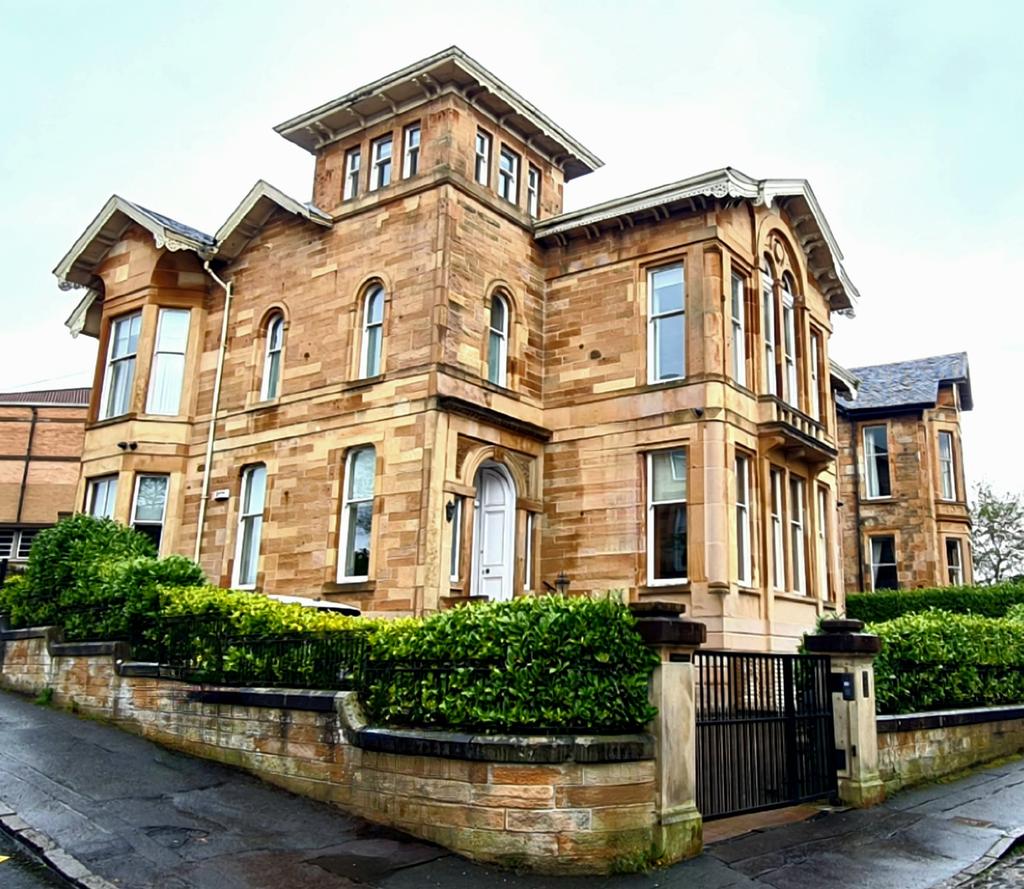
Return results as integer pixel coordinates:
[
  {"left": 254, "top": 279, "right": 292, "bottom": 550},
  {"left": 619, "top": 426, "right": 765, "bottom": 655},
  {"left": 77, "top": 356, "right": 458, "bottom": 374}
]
[{"left": 647, "top": 450, "right": 687, "bottom": 584}]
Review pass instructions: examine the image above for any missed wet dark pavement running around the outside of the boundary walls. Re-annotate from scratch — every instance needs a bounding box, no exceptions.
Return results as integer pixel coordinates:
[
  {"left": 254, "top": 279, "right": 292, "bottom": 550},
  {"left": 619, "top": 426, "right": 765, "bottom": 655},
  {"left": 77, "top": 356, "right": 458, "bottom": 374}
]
[{"left": 0, "top": 692, "right": 1024, "bottom": 889}]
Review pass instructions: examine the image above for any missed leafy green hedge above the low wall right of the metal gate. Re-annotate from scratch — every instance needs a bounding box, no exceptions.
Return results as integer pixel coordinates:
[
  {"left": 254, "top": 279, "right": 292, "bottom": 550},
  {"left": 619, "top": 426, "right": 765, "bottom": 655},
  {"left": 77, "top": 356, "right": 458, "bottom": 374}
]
[{"left": 866, "top": 610, "right": 1024, "bottom": 713}]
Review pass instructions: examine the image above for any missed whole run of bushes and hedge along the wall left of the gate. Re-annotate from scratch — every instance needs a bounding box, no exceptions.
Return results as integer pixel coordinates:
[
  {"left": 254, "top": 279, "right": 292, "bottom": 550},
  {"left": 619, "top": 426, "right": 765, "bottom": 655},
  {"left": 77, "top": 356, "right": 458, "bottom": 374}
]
[{"left": 0, "top": 516, "right": 656, "bottom": 732}]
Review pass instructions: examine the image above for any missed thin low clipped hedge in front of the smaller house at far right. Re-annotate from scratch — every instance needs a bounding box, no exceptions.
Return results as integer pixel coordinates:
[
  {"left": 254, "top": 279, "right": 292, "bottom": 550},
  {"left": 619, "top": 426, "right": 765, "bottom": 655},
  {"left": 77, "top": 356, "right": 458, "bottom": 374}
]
[{"left": 846, "top": 583, "right": 1024, "bottom": 623}]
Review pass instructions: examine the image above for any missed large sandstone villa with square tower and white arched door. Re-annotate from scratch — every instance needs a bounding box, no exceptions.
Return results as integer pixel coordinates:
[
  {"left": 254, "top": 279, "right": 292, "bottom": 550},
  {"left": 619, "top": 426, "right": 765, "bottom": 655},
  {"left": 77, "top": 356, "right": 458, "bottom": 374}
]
[{"left": 55, "top": 48, "right": 857, "bottom": 648}]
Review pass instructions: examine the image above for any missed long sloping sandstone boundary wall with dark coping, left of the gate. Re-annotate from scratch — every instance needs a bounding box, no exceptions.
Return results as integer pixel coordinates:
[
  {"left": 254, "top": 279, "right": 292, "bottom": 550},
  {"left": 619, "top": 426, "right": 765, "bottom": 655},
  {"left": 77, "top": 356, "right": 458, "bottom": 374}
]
[{"left": 0, "top": 628, "right": 656, "bottom": 874}]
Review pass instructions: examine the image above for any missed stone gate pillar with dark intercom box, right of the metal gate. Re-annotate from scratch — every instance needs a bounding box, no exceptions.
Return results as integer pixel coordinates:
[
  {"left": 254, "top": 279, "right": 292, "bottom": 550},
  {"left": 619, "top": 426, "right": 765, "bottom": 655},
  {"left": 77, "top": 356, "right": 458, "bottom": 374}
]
[{"left": 806, "top": 620, "right": 886, "bottom": 808}]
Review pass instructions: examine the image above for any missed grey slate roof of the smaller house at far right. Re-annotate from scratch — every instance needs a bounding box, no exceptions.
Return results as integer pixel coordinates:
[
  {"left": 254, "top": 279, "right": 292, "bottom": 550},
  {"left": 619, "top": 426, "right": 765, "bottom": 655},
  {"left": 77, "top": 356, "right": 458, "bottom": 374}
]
[{"left": 836, "top": 352, "right": 974, "bottom": 414}]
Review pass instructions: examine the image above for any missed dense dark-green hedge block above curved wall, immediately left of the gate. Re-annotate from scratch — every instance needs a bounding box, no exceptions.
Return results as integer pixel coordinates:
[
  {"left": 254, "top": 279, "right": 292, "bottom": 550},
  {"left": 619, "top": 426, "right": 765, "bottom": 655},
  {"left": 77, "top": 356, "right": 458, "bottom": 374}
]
[{"left": 361, "top": 596, "right": 656, "bottom": 731}]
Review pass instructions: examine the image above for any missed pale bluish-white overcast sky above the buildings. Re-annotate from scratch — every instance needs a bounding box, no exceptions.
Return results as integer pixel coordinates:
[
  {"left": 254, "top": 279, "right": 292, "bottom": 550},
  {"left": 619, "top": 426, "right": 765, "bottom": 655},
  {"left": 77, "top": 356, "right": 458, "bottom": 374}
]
[{"left": 0, "top": 0, "right": 1024, "bottom": 492}]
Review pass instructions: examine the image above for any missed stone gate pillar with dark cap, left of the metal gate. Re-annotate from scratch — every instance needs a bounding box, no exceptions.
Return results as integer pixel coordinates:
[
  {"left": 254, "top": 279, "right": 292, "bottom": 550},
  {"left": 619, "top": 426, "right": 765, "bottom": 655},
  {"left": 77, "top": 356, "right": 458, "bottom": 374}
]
[{"left": 630, "top": 602, "right": 708, "bottom": 862}]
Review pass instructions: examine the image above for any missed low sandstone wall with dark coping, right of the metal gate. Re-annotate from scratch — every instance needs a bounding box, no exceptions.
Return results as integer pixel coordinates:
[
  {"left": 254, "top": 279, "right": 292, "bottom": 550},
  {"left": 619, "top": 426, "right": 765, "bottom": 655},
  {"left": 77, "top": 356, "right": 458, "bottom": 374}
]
[{"left": 878, "top": 707, "right": 1024, "bottom": 794}]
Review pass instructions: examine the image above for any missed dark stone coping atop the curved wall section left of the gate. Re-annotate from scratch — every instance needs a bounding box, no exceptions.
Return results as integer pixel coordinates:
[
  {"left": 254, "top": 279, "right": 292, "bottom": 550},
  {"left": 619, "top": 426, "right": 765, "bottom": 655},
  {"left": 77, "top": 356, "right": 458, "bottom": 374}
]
[{"left": 350, "top": 727, "right": 654, "bottom": 764}]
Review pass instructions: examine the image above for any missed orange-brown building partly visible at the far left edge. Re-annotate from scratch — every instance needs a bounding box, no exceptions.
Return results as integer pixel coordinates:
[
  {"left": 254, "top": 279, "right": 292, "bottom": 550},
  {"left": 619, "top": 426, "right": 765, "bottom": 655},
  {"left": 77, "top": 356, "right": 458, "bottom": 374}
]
[{"left": 0, "top": 389, "right": 89, "bottom": 563}]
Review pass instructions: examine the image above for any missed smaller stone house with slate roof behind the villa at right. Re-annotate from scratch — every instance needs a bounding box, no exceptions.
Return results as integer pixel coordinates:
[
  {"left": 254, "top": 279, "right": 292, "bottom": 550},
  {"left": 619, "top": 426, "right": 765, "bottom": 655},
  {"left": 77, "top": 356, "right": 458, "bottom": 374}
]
[{"left": 838, "top": 352, "right": 974, "bottom": 592}]
